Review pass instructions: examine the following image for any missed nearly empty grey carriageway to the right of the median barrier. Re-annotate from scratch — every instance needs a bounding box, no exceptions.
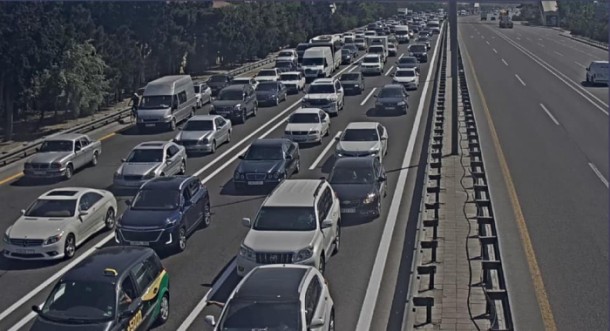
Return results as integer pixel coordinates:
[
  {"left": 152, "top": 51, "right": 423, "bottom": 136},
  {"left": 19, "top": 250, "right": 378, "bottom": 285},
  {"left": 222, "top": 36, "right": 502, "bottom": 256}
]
[{"left": 459, "top": 17, "right": 609, "bottom": 330}]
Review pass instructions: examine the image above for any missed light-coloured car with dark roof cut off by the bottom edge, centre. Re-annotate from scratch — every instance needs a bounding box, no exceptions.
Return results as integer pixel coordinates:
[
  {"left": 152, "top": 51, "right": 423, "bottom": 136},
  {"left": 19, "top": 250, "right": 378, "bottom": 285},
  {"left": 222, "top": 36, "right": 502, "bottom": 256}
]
[{"left": 205, "top": 266, "right": 335, "bottom": 331}]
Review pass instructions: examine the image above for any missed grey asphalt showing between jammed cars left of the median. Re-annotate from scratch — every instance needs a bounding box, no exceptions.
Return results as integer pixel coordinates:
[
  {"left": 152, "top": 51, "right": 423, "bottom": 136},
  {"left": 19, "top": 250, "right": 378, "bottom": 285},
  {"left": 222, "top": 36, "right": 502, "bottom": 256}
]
[{"left": 0, "top": 24, "right": 438, "bottom": 330}]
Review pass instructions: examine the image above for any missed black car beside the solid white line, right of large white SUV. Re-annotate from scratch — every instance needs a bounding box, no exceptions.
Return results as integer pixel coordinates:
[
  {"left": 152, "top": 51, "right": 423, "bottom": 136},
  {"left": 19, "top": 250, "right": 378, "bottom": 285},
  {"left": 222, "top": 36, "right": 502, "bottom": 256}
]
[{"left": 329, "top": 156, "right": 387, "bottom": 217}]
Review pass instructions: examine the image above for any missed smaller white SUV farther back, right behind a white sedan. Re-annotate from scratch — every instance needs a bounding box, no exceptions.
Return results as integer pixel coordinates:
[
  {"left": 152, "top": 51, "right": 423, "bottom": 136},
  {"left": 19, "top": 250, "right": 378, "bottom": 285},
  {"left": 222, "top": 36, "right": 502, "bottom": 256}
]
[{"left": 301, "top": 78, "right": 345, "bottom": 115}]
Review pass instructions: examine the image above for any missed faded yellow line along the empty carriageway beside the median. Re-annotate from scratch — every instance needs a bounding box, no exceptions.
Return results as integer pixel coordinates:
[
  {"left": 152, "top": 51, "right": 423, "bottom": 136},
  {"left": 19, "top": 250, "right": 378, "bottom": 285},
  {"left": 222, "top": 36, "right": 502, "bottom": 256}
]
[{"left": 460, "top": 31, "right": 557, "bottom": 331}]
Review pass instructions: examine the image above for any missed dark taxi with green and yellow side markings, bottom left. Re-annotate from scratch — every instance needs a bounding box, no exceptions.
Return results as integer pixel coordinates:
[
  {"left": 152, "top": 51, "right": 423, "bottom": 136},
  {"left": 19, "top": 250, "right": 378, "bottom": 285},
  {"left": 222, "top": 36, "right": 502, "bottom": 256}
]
[{"left": 31, "top": 246, "right": 169, "bottom": 331}]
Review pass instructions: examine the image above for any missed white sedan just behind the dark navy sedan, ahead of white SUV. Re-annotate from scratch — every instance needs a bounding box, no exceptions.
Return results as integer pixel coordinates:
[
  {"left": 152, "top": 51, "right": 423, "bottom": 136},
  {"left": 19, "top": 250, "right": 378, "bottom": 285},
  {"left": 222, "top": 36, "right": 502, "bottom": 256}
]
[{"left": 284, "top": 108, "right": 330, "bottom": 143}]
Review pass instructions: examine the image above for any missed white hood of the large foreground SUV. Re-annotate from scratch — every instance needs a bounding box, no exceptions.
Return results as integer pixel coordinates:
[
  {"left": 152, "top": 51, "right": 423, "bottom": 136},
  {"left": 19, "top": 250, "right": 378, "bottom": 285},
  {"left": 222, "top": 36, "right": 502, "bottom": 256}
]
[{"left": 244, "top": 229, "right": 316, "bottom": 253}]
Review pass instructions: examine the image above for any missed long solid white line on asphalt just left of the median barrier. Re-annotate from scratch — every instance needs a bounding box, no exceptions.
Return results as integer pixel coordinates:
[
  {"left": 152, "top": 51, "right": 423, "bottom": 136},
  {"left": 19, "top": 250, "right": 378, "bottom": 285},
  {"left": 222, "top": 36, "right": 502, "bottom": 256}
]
[{"left": 356, "top": 21, "right": 440, "bottom": 331}]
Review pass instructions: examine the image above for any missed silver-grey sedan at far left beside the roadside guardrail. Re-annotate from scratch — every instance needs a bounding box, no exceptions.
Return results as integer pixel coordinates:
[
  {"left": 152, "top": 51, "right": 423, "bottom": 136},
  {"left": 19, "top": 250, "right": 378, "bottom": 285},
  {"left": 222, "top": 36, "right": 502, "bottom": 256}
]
[{"left": 23, "top": 133, "right": 102, "bottom": 179}]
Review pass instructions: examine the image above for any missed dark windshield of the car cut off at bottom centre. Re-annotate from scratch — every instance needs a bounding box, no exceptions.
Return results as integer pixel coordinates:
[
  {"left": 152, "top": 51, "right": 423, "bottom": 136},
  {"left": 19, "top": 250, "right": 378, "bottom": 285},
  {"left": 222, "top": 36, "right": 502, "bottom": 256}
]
[{"left": 219, "top": 299, "right": 302, "bottom": 331}]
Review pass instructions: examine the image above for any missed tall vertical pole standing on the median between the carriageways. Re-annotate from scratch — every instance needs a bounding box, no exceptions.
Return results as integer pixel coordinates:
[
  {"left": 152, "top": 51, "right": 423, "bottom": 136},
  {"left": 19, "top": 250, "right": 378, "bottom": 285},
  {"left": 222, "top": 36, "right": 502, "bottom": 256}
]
[{"left": 449, "top": 0, "right": 459, "bottom": 155}]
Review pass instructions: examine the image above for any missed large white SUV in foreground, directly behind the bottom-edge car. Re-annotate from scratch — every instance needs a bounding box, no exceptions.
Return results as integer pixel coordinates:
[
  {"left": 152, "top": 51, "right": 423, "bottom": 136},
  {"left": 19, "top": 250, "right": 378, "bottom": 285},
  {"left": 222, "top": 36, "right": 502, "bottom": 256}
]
[{"left": 237, "top": 179, "right": 341, "bottom": 276}]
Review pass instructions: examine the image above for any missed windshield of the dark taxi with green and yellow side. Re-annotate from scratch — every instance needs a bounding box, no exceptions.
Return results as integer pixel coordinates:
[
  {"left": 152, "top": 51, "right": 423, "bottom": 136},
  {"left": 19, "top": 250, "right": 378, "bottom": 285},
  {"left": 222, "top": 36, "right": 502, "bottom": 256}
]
[{"left": 41, "top": 280, "right": 116, "bottom": 324}]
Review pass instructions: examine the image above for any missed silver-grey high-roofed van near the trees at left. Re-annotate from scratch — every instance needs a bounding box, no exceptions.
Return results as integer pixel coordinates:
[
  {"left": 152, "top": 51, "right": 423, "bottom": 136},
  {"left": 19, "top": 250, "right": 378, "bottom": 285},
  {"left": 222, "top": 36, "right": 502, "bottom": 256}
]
[{"left": 137, "top": 75, "right": 197, "bottom": 131}]
